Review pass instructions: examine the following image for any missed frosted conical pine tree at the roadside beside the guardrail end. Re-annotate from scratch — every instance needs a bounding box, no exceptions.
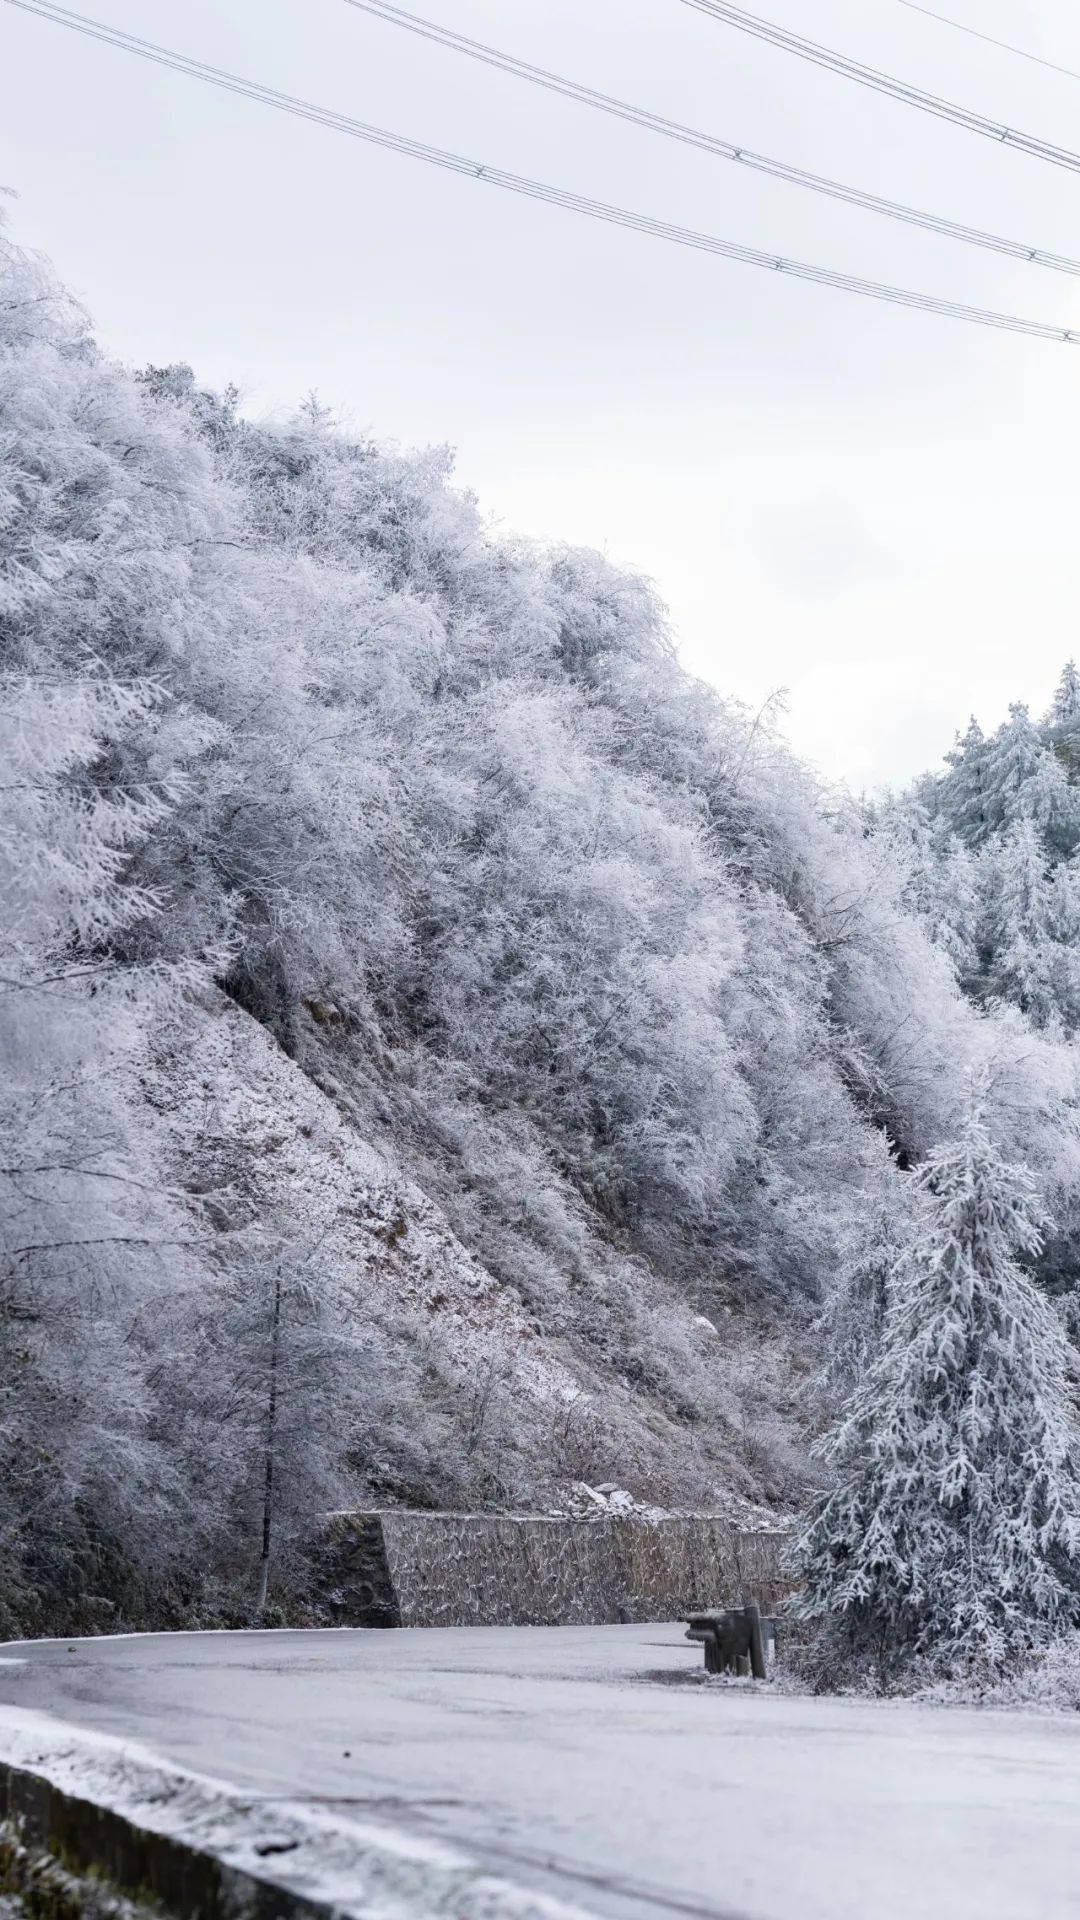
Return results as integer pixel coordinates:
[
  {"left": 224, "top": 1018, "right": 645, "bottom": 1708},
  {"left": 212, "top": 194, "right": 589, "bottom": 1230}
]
[{"left": 798, "top": 1092, "right": 1080, "bottom": 1676}]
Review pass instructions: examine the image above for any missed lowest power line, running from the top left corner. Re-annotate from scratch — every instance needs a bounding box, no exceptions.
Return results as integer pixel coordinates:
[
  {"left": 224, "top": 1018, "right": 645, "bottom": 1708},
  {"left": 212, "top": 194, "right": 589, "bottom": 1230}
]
[{"left": 6, "top": 0, "right": 1080, "bottom": 346}]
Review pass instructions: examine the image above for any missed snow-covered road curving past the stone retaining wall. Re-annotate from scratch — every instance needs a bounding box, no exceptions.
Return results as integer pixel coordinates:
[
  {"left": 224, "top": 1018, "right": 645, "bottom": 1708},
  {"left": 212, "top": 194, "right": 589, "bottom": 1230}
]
[{"left": 0, "top": 1624, "right": 1080, "bottom": 1920}]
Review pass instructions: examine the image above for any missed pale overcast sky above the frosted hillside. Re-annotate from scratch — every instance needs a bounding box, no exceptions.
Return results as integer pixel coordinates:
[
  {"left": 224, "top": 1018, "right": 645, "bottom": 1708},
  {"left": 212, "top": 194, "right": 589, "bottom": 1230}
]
[{"left": 0, "top": 0, "right": 1080, "bottom": 787}]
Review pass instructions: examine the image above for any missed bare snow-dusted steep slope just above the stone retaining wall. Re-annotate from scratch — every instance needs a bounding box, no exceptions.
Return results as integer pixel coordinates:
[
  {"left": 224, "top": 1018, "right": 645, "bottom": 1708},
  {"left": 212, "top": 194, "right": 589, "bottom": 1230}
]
[{"left": 133, "top": 991, "right": 801, "bottom": 1519}]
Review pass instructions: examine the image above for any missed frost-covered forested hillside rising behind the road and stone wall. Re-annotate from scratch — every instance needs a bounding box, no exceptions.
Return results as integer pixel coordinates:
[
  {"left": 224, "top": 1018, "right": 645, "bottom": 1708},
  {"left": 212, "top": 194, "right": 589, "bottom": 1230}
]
[{"left": 0, "top": 224, "right": 1080, "bottom": 1632}]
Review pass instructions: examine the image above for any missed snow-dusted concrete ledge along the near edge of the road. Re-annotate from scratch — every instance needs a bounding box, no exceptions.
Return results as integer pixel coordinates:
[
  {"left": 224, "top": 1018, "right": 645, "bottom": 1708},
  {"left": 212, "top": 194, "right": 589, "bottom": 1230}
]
[{"left": 0, "top": 1707, "right": 588, "bottom": 1920}]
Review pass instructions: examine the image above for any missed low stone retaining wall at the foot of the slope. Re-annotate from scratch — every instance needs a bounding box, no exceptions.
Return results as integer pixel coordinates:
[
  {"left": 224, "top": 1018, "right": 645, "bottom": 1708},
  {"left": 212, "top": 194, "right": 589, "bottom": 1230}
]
[{"left": 315, "top": 1509, "right": 786, "bottom": 1626}]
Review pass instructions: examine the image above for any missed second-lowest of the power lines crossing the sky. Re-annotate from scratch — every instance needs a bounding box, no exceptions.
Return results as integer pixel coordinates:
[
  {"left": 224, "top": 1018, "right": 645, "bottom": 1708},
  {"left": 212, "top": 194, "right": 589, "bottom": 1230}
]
[{"left": 338, "top": 0, "right": 1080, "bottom": 273}]
